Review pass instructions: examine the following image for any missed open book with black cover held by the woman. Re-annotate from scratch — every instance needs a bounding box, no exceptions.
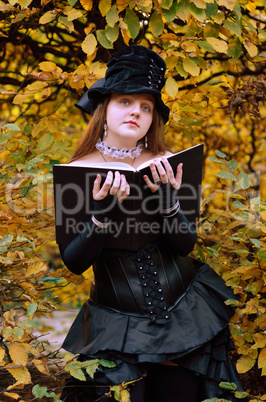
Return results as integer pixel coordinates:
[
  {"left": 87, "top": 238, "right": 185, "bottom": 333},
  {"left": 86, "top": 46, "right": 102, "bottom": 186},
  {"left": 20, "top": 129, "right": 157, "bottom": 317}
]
[{"left": 53, "top": 144, "right": 203, "bottom": 250}]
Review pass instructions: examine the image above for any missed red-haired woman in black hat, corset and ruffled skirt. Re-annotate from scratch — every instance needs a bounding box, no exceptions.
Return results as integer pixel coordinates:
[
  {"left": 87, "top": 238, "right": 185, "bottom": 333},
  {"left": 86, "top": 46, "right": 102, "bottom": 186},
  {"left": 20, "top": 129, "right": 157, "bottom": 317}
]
[{"left": 60, "top": 46, "right": 243, "bottom": 402}]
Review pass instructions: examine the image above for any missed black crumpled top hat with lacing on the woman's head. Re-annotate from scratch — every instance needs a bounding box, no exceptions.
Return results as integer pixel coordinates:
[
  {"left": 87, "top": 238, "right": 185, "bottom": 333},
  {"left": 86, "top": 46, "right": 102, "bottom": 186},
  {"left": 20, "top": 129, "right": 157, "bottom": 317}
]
[{"left": 75, "top": 46, "right": 169, "bottom": 123}]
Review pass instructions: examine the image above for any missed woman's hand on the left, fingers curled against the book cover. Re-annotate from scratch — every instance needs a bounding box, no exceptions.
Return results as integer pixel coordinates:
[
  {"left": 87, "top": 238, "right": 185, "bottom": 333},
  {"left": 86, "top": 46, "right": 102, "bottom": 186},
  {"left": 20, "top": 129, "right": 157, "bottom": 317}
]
[{"left": 92, "top": 171, "right": 130, "bottom": 202}]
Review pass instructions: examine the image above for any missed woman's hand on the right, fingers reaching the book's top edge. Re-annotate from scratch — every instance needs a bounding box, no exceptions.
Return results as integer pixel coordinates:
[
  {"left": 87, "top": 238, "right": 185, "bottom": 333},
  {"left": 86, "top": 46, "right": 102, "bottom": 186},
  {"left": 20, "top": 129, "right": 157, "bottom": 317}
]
[{"left": 143, "top": 157, "right": 183, "bottom": 193}]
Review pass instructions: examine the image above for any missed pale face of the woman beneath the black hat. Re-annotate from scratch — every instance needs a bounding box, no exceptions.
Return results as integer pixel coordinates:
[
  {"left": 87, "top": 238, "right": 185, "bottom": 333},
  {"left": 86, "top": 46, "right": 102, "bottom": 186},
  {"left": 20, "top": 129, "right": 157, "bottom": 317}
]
[{"left": 106, "top": 94, "right": 154, "bottom": 147}]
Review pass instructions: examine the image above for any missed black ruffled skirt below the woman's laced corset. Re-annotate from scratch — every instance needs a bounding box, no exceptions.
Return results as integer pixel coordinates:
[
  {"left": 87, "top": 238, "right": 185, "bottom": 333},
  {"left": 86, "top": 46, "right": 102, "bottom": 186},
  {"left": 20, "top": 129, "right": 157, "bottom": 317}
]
[{"left": 62, "top": 261, "right": 244, "bottom": 401}]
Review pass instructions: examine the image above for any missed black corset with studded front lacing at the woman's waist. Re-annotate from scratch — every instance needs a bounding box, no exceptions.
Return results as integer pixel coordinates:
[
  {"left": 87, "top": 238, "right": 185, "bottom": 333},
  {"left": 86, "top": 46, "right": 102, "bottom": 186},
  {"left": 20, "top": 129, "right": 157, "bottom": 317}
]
[{"left": 91, "top": 243, "right": 196, "bottom": 324}]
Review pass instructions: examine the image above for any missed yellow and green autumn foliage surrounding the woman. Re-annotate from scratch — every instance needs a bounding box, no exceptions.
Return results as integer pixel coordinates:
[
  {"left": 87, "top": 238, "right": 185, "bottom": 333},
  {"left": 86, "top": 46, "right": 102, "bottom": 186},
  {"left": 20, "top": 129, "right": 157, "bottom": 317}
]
[{"left": 0, "top": 0, "right": 266, "bottom": 401}]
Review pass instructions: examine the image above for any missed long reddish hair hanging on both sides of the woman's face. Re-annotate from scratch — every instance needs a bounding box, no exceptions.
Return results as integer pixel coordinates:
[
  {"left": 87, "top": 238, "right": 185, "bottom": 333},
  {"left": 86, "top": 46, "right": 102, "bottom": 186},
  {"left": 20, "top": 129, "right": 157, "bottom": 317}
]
[{"left": 69, "top": 96, "right": 165, "bottom": 162}]
